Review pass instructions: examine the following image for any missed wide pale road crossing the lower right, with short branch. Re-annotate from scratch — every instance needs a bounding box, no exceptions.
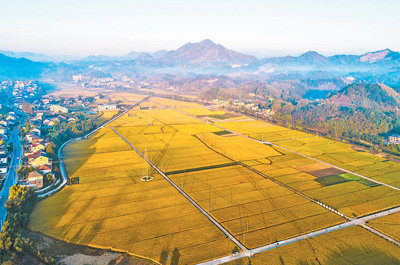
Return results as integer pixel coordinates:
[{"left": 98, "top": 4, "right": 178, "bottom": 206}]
[{"left": 199, "top": 204, "right": 400, "bottom": 265}]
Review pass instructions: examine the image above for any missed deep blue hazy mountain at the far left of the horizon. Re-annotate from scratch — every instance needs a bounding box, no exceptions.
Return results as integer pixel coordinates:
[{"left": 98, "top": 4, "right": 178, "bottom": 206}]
[{"left": 0, "top": 54, "right": 49, "bottom": 79}]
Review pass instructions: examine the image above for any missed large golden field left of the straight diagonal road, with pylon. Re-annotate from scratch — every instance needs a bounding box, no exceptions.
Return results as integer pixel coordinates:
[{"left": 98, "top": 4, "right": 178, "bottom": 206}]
[{"left": 29, "top": 129, "right": 239, "bottom": 264}]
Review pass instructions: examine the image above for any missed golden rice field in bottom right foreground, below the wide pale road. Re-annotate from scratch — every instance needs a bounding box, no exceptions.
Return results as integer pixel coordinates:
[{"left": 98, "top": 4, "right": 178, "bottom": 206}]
[{"left": 227, "top": 226, "right": 400, "bottom": 265}]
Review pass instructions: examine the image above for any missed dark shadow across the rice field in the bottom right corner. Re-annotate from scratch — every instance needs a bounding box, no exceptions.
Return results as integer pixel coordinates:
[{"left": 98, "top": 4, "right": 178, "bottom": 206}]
[{"left": 296, "top": 246, "right": 400, "bottom": 265}]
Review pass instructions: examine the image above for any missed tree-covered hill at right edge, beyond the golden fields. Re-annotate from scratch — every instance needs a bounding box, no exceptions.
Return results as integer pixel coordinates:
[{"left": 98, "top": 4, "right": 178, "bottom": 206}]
[{"left": 282, "top": 84, "right": 400, "bottom": 154}]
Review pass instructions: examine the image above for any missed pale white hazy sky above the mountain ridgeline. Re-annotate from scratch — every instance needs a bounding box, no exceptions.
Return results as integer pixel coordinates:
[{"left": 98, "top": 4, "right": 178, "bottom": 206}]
[{"left": 0, "top": 0, "right": 400, "bottom": 56}]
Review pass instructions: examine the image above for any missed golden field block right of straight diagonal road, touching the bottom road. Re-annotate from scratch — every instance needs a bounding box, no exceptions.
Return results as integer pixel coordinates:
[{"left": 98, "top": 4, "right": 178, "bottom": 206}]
[{"left": 170, "top": 166, "right": 344, "bottom": 248}]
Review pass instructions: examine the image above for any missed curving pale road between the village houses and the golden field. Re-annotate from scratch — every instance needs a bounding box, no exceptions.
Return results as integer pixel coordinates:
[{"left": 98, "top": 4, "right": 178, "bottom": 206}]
[{"left": 38, "top": 96, "right": 150, "bottom": 198}]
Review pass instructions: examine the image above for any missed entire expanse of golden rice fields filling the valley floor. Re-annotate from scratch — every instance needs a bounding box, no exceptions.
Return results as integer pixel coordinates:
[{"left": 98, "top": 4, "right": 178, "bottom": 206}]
[{"left": 29, "top": 98, "right": 400, "bottom": 264}]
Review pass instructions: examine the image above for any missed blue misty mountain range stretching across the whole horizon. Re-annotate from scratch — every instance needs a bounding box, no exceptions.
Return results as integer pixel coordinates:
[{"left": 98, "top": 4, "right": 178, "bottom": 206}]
[{"left": 0, "top": 39, "right": 400, "bottom": 85}]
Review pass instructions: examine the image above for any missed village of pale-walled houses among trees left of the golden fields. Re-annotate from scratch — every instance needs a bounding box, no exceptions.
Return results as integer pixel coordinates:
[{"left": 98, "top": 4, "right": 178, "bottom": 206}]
[{"left": 0, "top": 81, "right": 117, "bottom": 194}]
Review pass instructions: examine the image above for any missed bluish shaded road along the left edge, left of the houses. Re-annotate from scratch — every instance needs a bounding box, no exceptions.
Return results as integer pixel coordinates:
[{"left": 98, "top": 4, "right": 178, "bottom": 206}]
[{"left": 0, "top": 129, "right": 22, "bottom": 227}]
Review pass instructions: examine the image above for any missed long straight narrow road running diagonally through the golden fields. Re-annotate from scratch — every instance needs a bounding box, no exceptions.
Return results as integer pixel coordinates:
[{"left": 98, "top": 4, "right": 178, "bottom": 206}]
[{"left": 111, "top": 127, "right": 248, "bottom": 253}]
